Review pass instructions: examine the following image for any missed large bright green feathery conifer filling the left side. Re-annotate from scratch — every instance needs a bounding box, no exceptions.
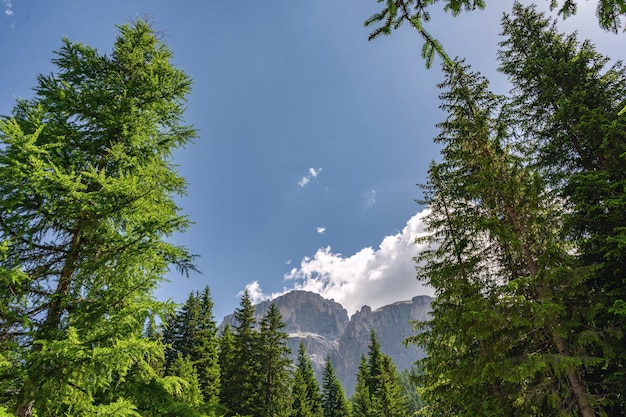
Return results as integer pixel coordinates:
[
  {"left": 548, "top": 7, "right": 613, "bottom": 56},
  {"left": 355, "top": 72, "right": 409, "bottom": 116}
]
[{"left": 0, "top": 21, "right": 195, "bottom": 417}]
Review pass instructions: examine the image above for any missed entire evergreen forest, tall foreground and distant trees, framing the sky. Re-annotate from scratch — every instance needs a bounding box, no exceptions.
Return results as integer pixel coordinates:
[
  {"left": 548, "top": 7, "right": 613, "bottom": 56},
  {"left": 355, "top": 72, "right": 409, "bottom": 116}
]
[{"left": 0, "top": 0, "right": 626, "bottom": 417}]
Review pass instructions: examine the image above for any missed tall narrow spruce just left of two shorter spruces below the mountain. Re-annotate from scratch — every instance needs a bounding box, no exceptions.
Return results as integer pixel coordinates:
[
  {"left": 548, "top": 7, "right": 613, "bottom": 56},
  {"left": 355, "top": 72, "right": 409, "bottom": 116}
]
[{"left": 257, "top": 303, "right": 292, "bottom": 417}]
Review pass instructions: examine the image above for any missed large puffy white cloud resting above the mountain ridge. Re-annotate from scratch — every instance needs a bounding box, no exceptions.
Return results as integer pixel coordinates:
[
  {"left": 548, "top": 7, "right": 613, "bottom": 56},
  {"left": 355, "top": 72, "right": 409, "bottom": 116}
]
[{"left": 243, "top": 211, "right": 433, "bottom": 314}]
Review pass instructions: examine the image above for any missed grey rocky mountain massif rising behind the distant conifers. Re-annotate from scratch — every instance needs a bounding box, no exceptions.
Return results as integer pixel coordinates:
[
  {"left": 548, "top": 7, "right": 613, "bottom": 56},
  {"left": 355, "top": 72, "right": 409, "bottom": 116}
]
[{"left": 220, "top": 291, "right": 432, "bottom": 395}]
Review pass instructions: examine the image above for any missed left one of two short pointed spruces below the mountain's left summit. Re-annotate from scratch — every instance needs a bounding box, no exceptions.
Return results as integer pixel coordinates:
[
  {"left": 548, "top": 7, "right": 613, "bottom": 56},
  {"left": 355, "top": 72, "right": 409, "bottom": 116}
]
[{"left": 290, "top": 341, "right": 323, "bottom": 417}]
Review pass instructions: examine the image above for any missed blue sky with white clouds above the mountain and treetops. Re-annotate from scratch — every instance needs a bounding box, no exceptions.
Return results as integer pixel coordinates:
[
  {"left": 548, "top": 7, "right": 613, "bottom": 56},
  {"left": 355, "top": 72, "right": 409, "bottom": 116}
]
[{"left": 0, "top": 0, "right": 624, "bottom": 321}]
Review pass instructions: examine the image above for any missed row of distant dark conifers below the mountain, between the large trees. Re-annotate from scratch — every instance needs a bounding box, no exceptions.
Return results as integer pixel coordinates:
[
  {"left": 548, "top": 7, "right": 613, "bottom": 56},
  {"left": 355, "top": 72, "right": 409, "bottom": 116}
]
[{"left": 155, "top": 287, "right": 416, "bottom": 417}]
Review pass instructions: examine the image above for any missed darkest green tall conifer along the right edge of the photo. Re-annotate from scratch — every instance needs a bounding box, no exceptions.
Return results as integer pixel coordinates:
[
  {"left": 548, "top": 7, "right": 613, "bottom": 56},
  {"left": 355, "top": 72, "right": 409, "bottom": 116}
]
[{"left": 499, "top": 5, "right": 626, "bottom": 416}]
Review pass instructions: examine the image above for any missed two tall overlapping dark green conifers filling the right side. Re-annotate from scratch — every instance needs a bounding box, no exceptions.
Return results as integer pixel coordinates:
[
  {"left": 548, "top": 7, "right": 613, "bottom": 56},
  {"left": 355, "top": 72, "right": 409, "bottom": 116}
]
[{"left": 404, "top": 5, "right": 626, "bottom": 416}]
